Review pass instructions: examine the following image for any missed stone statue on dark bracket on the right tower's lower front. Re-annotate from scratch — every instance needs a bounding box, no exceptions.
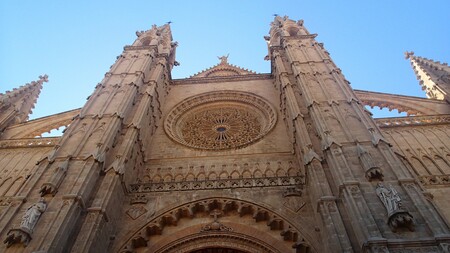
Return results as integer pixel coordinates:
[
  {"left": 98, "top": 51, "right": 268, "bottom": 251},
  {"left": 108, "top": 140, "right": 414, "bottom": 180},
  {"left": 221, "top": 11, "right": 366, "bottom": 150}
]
[{"left": 376, "top": 183, "right": 414, "bottom": 232}]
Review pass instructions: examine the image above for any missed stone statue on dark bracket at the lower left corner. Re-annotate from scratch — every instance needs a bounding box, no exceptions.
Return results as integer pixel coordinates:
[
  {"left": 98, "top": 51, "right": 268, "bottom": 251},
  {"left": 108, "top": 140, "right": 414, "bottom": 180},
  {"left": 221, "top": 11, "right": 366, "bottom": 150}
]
[{"left": 3, "top": 199, "right": 47, "bottom": 247}]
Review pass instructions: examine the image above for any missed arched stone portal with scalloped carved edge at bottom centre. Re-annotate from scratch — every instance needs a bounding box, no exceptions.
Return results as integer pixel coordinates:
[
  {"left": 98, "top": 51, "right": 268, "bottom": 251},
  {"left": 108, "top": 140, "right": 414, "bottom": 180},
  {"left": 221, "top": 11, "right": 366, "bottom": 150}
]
[{"left": 116, "top": 198, "right": 317, "bottom": 253}]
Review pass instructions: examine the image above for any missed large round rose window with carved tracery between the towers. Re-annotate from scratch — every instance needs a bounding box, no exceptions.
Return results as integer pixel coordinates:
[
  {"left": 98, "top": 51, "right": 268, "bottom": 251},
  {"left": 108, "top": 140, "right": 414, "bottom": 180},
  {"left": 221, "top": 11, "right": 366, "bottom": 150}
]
[{"left": 164, "top": 91, "right": 277, "bottom": 150}]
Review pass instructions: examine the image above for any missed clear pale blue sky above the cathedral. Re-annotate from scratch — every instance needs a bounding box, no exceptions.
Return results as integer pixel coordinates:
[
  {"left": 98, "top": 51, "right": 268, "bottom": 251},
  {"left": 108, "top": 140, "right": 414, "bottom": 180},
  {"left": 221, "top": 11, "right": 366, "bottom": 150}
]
[{"left": 0, "top": 0, "right": 450, "bottom": 122}]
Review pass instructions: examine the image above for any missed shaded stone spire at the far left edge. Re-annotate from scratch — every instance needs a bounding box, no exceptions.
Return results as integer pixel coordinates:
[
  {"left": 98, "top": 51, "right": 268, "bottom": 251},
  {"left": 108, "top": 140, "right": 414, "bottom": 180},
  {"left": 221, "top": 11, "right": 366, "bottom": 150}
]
[{"left": 0, "top": 75, "right": 48, "bottom": 133}]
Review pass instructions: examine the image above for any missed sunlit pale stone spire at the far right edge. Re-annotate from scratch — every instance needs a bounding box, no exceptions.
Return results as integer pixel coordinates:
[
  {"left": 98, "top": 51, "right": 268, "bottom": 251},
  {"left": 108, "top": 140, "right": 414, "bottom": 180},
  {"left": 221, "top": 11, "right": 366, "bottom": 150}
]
[{"left": 405, "top": 52, "right": 450, "bottom": 102}]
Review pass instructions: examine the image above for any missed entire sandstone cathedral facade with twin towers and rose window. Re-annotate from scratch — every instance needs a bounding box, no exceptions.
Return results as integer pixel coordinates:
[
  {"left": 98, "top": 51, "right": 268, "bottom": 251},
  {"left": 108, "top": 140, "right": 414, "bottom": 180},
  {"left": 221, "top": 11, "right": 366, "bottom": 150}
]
[{"left": 0, "top": 16, "right": 450, "bottom": 253}]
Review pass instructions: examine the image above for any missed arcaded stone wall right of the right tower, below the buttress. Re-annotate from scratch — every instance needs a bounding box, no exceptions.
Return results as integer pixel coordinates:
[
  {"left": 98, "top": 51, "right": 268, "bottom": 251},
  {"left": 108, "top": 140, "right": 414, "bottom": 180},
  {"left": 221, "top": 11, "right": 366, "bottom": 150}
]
[{"left": 383, "top": 125, "right": 450, "bottom": 224}]
